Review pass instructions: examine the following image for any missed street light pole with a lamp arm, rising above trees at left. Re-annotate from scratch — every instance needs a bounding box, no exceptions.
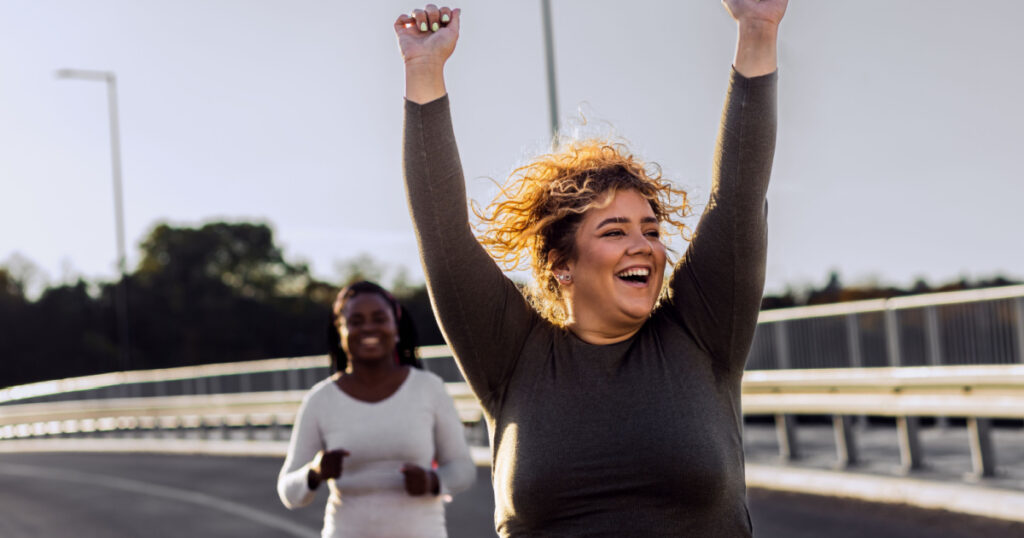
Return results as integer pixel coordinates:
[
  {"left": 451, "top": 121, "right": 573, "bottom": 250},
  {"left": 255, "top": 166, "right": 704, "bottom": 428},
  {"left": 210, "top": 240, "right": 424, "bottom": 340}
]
[{"left": 56, "top": 69, "right": 131, "bottom": 370}]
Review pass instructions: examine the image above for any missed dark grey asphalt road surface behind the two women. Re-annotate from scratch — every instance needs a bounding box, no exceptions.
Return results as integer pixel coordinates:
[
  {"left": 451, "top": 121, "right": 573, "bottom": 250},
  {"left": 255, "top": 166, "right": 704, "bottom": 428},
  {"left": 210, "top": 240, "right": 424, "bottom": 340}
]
[{"left": 0, "top": 454, "right": 1024, "bottom": 538}]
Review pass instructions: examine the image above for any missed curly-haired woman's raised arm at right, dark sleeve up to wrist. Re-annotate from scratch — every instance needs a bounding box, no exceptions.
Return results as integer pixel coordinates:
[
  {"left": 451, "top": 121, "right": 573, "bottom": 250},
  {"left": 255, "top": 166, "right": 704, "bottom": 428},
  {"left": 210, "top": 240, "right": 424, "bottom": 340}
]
[{"left": 667, "top": 26, "right": 777, "bottom": 375}]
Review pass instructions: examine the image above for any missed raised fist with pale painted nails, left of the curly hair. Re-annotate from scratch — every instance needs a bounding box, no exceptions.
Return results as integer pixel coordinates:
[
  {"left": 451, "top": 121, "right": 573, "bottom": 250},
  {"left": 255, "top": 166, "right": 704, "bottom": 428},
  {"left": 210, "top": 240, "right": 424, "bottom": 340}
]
[{"left": 394, "top": 4, "right": 462, "bottom": 68}]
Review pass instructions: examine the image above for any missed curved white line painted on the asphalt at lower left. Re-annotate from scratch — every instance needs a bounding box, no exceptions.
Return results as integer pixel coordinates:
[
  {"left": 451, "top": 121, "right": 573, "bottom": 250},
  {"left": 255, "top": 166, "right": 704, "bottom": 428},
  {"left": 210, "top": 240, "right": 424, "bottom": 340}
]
[{"left": 0, "top": 463, "right": 319, "bottom": 538}]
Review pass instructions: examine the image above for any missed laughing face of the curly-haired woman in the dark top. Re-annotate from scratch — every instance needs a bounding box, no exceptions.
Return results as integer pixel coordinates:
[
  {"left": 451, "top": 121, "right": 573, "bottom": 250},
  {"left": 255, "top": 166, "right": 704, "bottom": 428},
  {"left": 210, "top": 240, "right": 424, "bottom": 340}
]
[{"left": 555, "top": 190, "right": 666, "bottom": 342}]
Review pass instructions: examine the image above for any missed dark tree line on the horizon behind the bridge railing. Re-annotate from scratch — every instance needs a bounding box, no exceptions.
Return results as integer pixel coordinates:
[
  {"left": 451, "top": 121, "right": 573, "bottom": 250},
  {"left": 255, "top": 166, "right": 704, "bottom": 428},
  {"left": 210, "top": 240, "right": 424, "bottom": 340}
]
[{"left": 0, "top": 222, "right": 1018, "bottom": 386}]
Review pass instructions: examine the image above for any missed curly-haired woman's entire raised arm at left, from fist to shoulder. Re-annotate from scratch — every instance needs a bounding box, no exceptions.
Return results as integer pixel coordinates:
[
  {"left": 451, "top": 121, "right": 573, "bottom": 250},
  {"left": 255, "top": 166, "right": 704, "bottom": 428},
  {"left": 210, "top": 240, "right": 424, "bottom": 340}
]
[{"left": 395, "top": 5, "right": 539, "bottom": 411}]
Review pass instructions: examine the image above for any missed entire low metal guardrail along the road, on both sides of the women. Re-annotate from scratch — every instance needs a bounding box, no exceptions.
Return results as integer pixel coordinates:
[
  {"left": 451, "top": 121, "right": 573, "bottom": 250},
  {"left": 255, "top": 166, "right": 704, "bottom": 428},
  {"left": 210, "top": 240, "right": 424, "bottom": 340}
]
[{"left": 0, "top": 365, "right": 1024, "bottom": 477}]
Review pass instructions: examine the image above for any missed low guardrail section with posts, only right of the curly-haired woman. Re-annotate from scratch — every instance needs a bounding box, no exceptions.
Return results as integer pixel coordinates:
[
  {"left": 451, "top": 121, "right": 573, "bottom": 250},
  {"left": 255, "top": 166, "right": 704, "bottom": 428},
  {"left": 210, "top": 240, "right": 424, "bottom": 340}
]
[{"left": 742, "top": 365, "right": 1024, "bottom": 477}]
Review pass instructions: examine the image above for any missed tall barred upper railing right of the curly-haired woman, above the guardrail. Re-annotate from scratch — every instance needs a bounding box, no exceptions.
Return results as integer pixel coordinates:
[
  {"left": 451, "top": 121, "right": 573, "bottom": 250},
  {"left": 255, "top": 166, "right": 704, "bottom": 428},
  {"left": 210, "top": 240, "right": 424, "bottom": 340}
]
[{"left": 746, "top": 285, "right": 1024, "bottom": 370}]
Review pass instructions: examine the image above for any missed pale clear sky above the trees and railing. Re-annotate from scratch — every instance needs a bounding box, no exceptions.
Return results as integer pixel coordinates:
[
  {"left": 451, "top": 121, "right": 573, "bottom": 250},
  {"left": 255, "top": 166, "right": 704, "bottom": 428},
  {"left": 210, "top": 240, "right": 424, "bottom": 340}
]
[{"left": 0, "top": 0, "right": 1024, "bottom": 293}]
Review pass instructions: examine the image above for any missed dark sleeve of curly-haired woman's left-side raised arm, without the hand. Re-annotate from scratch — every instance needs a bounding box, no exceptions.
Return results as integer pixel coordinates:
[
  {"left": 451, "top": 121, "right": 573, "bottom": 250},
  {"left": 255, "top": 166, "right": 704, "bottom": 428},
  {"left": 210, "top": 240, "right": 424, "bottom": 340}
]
[{"left": 402, "top": 95, "right": 539, "bottom": 401}]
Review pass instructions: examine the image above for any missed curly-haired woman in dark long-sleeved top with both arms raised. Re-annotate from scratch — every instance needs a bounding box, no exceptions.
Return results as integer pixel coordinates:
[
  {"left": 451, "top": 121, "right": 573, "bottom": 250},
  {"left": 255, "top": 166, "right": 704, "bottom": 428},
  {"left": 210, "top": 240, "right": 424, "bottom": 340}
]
[{"left": 394, "top": 0, "right": 786, "bottom": 536}]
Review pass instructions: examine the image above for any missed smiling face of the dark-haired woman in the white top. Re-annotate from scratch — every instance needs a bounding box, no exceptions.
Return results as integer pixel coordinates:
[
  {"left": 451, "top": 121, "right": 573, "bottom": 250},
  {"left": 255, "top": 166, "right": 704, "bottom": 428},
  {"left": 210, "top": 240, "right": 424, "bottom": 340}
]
[{"left": 338, "top": 293, "right": 398, "bottom": 361}]
